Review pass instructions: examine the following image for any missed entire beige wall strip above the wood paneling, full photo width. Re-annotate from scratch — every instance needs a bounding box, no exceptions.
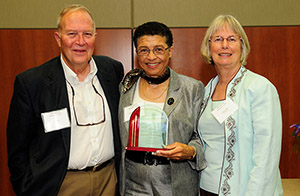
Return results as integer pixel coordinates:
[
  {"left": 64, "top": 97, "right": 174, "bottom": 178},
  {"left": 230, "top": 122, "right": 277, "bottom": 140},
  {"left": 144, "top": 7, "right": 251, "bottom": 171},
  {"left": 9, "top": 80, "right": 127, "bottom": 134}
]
[{"left": 0, "top": 0, "right": 300, "bottom": 28}]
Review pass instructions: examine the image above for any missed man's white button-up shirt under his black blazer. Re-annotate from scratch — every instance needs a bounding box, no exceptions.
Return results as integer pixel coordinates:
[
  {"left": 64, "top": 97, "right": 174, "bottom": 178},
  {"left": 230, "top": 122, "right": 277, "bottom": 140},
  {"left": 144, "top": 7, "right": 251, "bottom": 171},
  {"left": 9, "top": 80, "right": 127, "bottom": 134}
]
[{"left": 61, "top": 57, "right": 114, "bottom": 169}]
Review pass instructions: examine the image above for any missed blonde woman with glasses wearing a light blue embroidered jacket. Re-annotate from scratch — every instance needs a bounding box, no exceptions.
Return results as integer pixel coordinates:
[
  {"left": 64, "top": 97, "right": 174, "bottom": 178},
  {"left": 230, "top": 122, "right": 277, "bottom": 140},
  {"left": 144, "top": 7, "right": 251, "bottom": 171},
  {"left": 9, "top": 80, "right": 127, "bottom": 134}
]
[{"left": 198, "top": 15, "right": 283, "bottom": 196}]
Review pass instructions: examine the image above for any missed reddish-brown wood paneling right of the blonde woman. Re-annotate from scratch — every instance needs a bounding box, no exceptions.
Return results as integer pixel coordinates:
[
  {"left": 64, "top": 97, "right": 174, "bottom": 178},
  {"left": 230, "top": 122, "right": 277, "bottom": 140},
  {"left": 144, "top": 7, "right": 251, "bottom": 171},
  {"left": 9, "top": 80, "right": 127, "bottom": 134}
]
[{"left": 246, "top": 27, "right": 300, "bottom": 178}]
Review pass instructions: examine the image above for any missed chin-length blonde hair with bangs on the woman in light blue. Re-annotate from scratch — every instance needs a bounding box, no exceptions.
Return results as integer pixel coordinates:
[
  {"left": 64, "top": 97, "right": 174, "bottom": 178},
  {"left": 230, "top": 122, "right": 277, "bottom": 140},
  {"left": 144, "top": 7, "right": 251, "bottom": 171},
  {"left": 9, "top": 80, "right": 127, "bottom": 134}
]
[{"left": 201, "top": 15, "right": 250, "bottom": 65}]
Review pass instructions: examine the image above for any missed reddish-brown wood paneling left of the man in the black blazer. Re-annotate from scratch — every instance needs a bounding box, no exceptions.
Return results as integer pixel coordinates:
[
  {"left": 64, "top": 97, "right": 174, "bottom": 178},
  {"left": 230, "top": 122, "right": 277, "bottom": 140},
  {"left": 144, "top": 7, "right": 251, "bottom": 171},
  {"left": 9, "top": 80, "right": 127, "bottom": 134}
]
[{"left": 0, "top": 30, "right": 59, "bottom": 195}]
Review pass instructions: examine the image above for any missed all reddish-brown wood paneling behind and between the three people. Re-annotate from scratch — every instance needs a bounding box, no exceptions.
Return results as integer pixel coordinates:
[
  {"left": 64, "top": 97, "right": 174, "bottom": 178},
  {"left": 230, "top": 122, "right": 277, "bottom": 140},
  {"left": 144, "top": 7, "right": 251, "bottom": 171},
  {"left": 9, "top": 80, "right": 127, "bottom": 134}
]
[{"left": 0, "top": 26, "right": 300, "bottom": 196}]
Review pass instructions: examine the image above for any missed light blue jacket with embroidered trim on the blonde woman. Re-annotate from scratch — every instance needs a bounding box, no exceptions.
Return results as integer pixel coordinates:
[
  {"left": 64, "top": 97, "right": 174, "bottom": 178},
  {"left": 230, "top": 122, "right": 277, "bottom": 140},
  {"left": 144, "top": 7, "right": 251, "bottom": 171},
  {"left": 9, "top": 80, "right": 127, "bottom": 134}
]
[{"left": 199, "top": 66, "right": 283, "bottom": 196}]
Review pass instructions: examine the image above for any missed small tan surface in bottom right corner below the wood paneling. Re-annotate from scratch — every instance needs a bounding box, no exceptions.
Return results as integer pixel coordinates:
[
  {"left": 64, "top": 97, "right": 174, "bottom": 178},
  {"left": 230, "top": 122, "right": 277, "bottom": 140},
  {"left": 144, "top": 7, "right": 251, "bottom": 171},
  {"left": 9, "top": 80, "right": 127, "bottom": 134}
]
[{"left": 281, "top": 178, "right": 300, "bottom": 196}]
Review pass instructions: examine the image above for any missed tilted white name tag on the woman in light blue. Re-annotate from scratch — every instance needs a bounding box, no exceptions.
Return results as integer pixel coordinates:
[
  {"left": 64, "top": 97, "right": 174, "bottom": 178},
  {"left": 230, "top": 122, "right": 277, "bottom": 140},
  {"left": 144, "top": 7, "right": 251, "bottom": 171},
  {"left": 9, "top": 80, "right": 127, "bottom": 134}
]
[{"left": 211, "top": 98, "right": 238, "bottom": 124}]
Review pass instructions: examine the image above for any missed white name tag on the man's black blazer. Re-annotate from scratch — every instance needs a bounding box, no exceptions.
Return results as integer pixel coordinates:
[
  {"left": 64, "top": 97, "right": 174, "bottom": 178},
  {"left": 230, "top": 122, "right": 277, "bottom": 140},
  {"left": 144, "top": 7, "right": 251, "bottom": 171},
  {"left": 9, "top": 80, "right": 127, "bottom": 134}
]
[{"left": 41, "top": 108, "right": 71, "bottom": 133}]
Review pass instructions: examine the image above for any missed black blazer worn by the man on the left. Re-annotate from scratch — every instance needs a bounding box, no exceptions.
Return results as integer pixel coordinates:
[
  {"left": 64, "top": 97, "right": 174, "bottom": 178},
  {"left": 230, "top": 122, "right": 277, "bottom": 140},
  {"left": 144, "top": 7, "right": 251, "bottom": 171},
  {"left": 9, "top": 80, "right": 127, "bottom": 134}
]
[{"left": 7, "top": 56, "right": 124, "bottom": 196}]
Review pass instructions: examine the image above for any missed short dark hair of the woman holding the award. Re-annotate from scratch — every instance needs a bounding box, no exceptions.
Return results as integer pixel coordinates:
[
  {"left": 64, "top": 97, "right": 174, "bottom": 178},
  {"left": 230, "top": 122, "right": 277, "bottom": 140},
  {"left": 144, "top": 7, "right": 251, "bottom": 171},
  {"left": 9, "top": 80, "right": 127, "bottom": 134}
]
[{"left": 133, "top": 22, "right": 173, "bottom": 48}]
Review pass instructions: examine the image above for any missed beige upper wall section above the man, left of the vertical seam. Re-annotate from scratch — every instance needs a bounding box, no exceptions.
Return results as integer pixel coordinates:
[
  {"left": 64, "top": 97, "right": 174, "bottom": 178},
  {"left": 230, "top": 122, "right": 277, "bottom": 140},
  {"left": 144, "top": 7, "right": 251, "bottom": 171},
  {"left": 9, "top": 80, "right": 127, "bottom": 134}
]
[{"left": 0, "top": 0, "right": 131, "bottom": 28}]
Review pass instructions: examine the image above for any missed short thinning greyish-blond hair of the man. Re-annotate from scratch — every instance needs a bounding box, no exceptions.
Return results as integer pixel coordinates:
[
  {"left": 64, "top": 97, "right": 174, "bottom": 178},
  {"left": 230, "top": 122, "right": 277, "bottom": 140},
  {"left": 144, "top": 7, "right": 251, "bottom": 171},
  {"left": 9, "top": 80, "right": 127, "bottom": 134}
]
[{"left": 57, "top": 4, "right": 96, "bottom": 35}]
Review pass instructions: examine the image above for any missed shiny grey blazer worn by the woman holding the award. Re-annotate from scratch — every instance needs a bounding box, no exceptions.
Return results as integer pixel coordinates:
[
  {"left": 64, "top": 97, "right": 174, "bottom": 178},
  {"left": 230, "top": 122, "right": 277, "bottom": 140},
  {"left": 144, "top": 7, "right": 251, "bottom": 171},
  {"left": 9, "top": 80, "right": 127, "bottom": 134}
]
[{"left": 119, "top": 69, "right": 205, "bottom": 196}]
